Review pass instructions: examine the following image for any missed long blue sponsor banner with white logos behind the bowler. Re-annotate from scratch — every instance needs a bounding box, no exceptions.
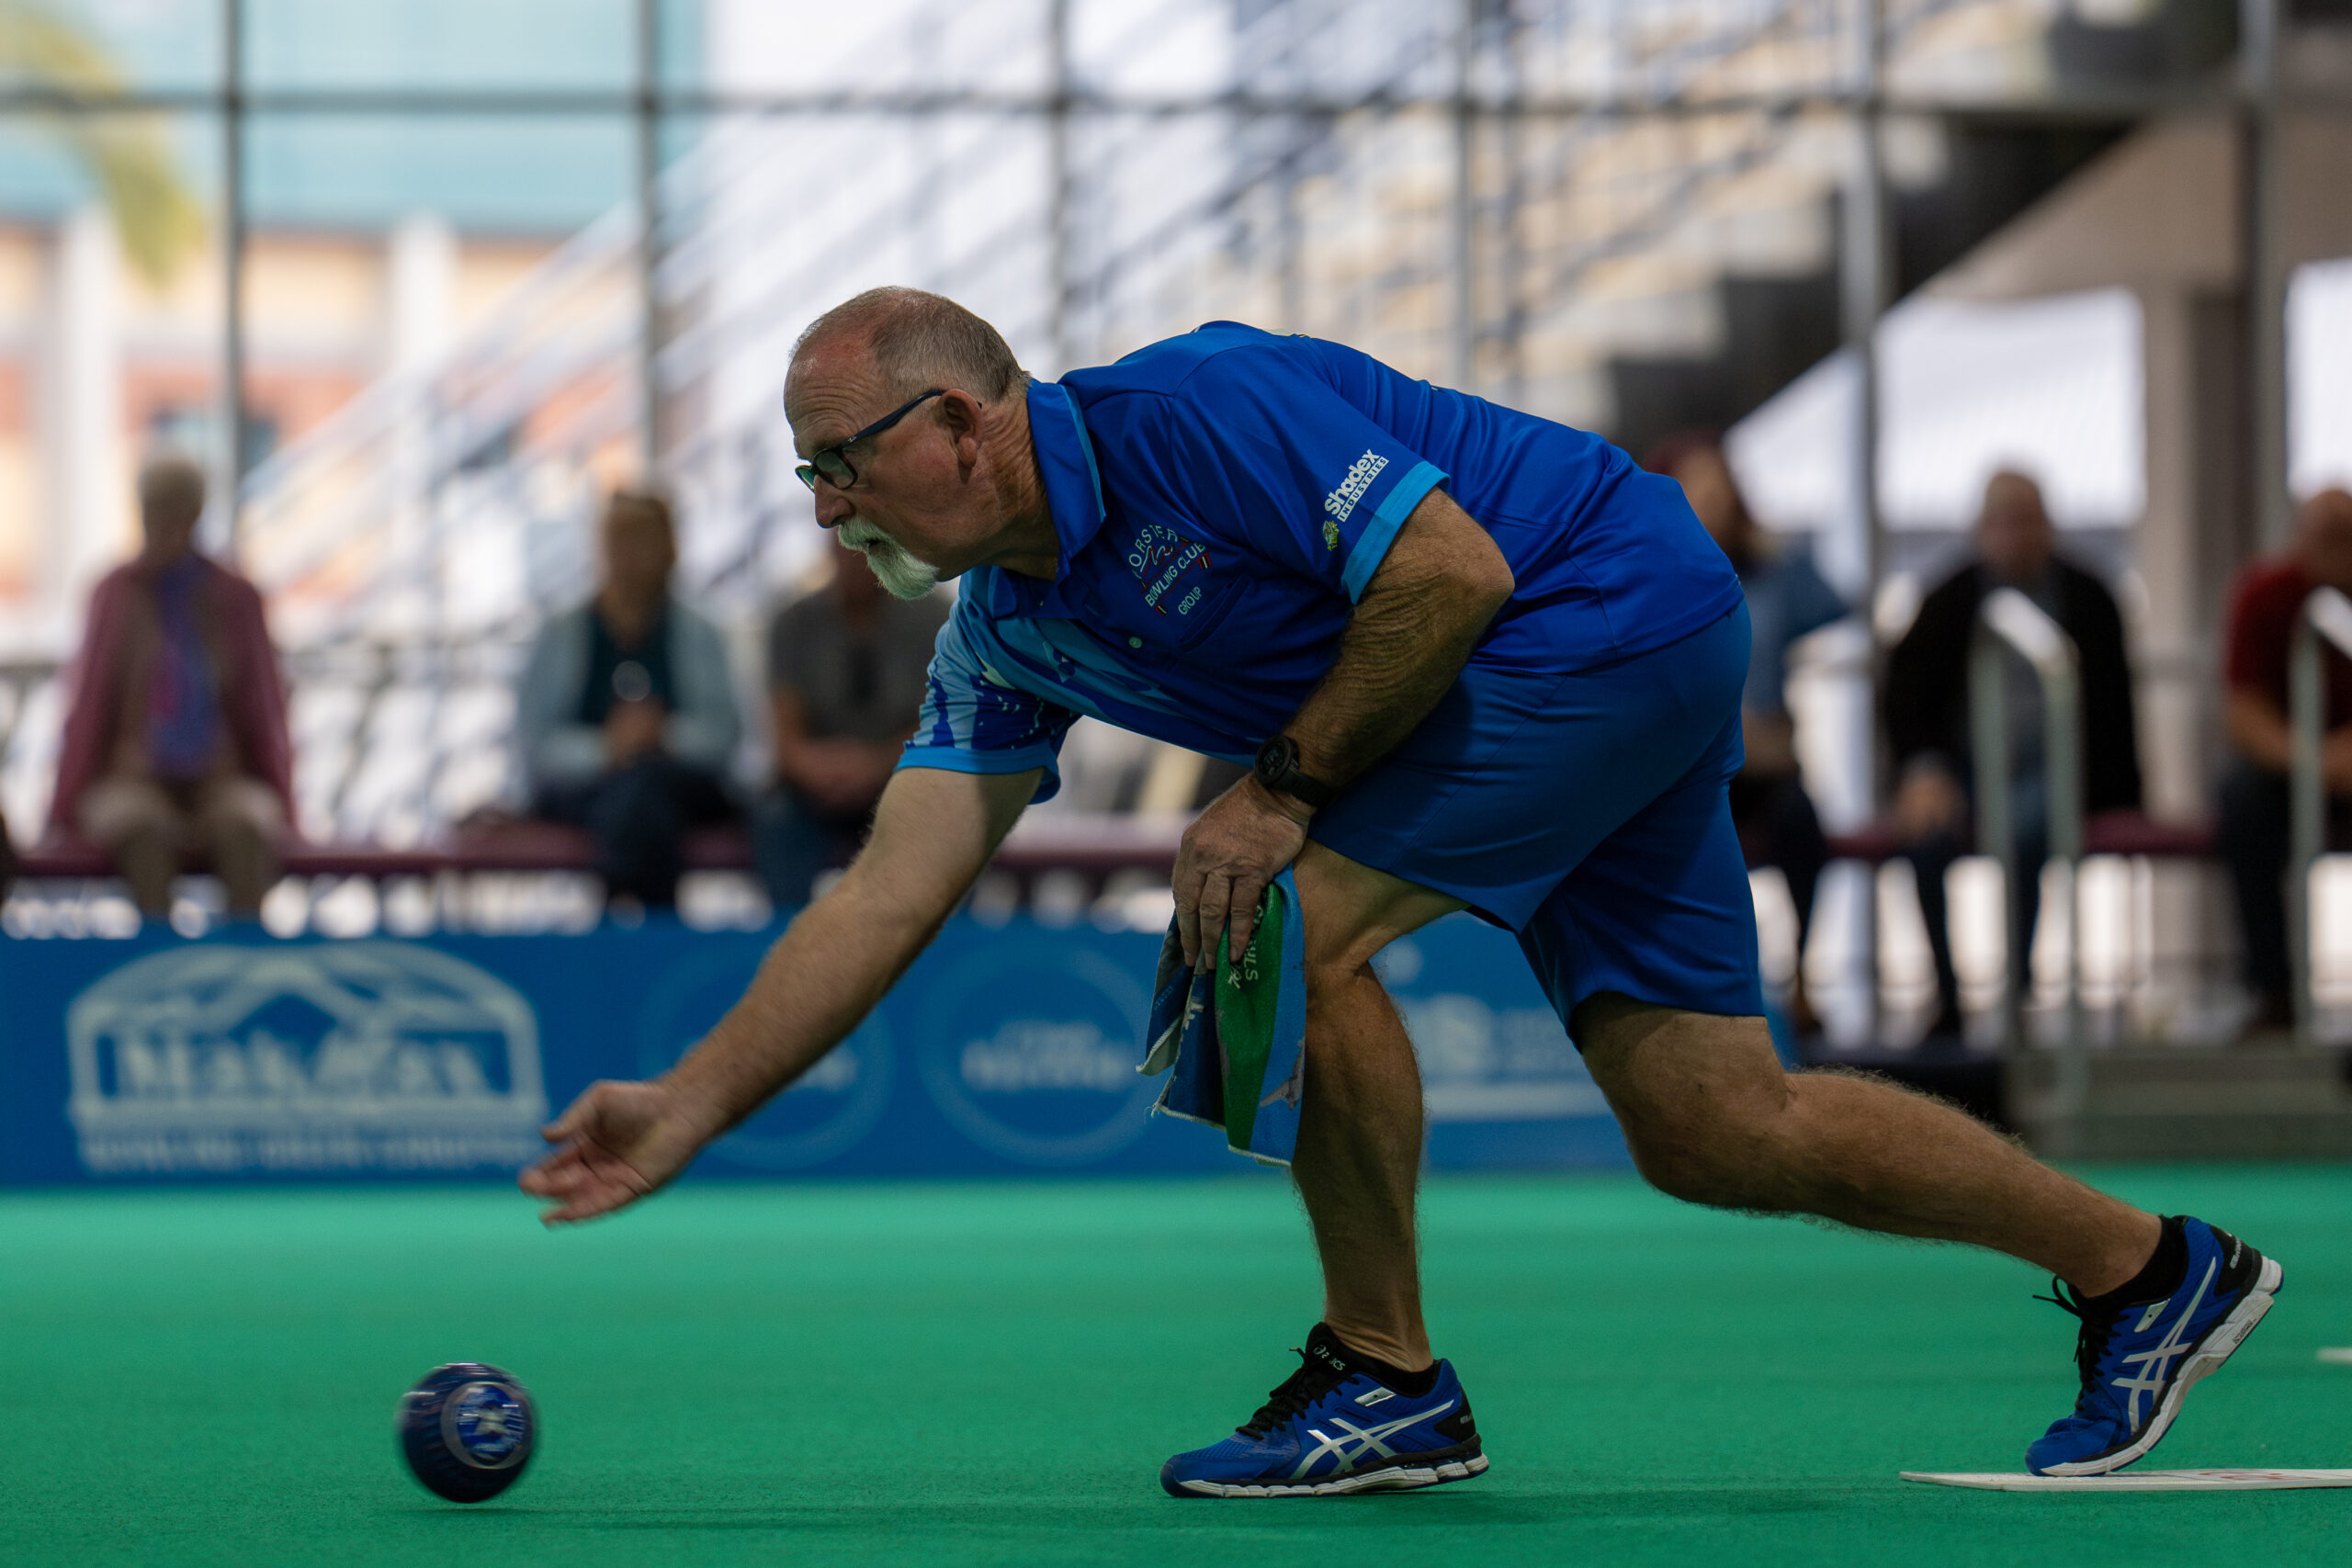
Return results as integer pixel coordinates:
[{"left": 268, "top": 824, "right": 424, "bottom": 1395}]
[{"left": 0, "top": 917, "right": 1625, "bottom": 1182}]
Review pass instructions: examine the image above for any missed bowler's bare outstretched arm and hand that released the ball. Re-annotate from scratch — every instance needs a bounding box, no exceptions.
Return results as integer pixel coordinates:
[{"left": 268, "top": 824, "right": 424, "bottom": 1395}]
[{"left": 522, "top": 769, "right": 1040, "bottom": 1224}]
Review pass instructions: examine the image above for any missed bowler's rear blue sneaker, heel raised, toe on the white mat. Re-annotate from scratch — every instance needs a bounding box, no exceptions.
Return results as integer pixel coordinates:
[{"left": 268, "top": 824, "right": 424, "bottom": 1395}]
[{"left": 2025, "top": 1218, "right": 2286, "bottom": 1476}]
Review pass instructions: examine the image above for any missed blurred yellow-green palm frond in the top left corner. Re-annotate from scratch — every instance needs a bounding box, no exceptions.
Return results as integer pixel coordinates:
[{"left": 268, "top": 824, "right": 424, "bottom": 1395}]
[{"left": 0, "top": 0, "right": 205, "bottom": 287}]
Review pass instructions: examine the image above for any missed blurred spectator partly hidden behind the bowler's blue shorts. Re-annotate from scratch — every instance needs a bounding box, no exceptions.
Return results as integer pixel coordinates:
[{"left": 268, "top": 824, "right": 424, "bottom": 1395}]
[{"left": 1644, "top": 434, "right": 1849, "bottom": 1034}]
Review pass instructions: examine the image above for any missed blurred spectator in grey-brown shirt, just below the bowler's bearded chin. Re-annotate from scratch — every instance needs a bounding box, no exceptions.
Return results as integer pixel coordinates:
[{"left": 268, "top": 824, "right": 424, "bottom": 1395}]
[{"left": 755, "top": 541, "right": 950, "bottom": 908}]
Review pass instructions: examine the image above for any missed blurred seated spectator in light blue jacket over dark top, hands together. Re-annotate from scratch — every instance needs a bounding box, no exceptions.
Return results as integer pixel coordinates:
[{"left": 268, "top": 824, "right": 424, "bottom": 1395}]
[{"left": 515, "top": 491, "right": 743, "bottom": 908}]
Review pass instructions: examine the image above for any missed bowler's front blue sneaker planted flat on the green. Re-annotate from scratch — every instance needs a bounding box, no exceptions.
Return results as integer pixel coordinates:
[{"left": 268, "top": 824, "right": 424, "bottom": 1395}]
[{"left": 1159, "top": 1324, "right": 1487, "bottom": 1497}]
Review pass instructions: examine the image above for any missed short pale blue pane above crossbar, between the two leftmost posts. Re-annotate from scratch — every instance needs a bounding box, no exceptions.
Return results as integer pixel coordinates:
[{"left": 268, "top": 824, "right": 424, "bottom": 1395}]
[{"left": 244, "top": 0, "right": 638, "bottom": 92}]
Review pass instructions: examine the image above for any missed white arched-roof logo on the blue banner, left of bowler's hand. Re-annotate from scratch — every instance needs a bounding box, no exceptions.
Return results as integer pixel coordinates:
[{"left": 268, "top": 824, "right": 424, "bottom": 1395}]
[{"left": 66, "top": 941, "right": 548, "bottom": 1176}]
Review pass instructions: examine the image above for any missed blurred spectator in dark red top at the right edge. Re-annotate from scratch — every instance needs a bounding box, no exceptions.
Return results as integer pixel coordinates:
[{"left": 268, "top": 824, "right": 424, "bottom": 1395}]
[{"left": 2221, "top": 489, "right": 2352, "bottom": 1032}]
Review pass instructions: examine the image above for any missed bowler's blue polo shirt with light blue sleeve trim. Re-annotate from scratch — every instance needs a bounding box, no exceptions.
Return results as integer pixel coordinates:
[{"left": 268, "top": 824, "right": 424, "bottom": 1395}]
[{"left": 900, "top": 322, "right": 1740, "bottom": 799}]
